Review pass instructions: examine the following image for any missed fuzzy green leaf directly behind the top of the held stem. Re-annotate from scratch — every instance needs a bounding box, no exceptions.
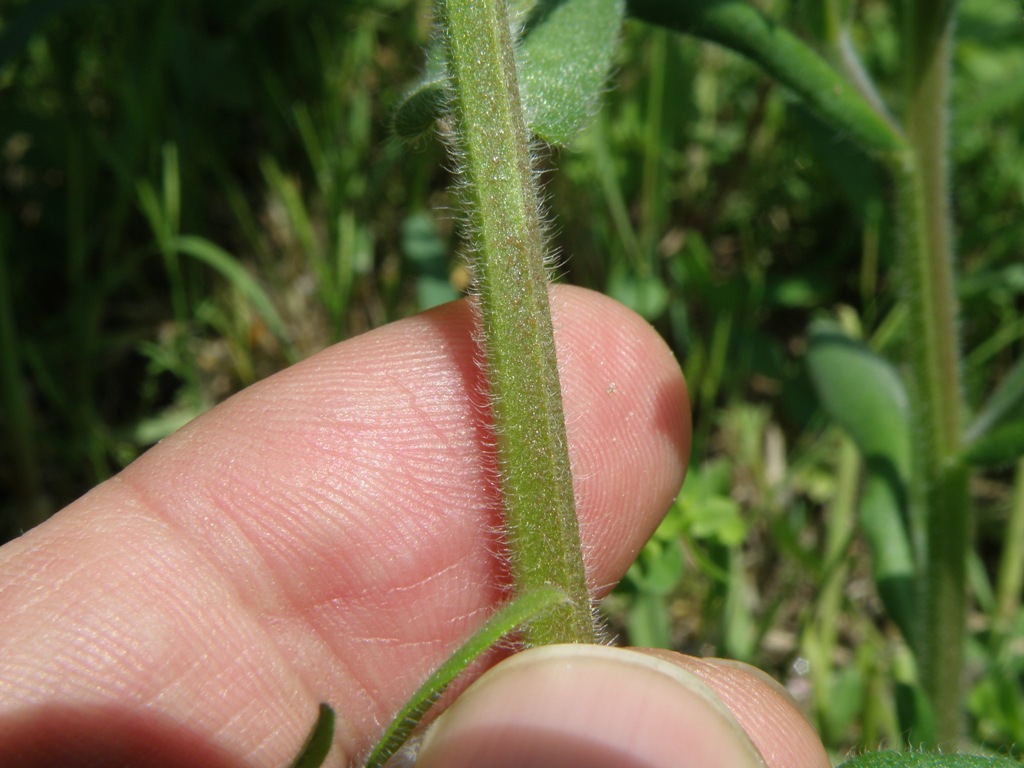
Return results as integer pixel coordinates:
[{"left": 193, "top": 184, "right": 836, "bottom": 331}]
[{"left": 518, "top": 0, "right": 626, "bottom": 144}]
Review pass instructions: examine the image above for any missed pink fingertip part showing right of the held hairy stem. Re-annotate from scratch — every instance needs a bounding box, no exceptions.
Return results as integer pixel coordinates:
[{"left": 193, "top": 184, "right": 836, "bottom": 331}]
[{"left": 552, "top": 287, "right": 691, "bottom": 586}]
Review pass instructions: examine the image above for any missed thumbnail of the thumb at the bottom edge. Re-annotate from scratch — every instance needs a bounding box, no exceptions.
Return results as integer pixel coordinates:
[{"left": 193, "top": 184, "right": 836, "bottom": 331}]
[{"left": 417, "top": 645, "right": 770, "bottom": 768}]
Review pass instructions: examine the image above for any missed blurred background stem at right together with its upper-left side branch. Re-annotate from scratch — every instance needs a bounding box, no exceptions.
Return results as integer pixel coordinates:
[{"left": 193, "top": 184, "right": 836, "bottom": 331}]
[{"left": 629, "top": 0, "right": 971, "bottom": 742}]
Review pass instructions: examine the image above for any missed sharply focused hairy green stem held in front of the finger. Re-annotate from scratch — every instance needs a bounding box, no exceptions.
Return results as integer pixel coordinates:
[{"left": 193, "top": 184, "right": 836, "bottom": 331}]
[{"left": 438, "top": 0, "right": 595, "bottom": 644}]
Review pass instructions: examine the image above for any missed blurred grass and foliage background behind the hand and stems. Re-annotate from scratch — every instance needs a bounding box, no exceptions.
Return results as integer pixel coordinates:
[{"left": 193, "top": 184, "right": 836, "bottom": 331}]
[{"left": 0, "top": 0, "right": 1024, "bottom": 752}]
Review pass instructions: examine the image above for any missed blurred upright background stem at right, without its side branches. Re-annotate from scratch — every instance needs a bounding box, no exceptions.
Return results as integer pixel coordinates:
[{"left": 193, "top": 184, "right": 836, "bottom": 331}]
[{"left": 896, "top": 2, "right": 970, "bottom": 744}]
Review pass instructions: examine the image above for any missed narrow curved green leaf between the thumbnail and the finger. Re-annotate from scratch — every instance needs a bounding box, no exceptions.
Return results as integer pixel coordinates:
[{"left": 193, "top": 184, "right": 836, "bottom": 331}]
[{"left": 366, "top": 589, "right": 568, "bottom": 768}]
